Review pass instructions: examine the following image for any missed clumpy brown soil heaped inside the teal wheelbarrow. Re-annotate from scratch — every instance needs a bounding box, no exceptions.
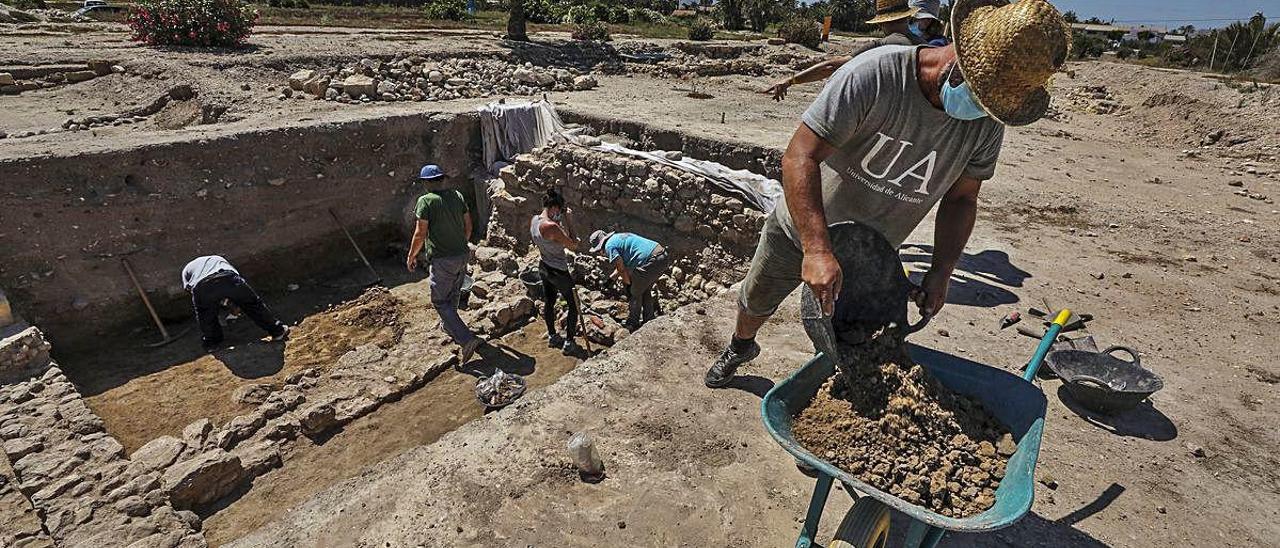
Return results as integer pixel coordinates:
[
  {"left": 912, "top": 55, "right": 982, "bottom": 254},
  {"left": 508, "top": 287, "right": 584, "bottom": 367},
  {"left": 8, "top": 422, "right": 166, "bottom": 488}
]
[{"left": 792, "top": 342, "right": 1016, "bottom": 517}]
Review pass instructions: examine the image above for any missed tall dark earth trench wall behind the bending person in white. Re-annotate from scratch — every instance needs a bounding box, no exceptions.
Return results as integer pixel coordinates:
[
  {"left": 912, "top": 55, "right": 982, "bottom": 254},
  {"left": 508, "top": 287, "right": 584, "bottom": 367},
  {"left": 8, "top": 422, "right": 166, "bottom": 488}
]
[{"left": 0, "top": 113, "right": 480, "bottom": 342}]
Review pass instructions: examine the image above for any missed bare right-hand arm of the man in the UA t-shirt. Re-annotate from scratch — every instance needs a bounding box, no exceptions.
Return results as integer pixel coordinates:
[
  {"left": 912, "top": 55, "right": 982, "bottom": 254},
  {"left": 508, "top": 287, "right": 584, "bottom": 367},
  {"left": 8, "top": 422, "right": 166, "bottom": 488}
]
[{"left": 915, "top": 177, "right": 982, "bottom": 316}]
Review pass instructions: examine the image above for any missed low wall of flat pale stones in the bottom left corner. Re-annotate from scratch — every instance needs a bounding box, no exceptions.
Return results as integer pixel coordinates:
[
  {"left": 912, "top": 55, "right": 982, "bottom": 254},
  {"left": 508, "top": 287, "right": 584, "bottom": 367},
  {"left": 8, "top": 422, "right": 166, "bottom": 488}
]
[{"left": 0, "top": 329, "right": 205, "bottom": 547}]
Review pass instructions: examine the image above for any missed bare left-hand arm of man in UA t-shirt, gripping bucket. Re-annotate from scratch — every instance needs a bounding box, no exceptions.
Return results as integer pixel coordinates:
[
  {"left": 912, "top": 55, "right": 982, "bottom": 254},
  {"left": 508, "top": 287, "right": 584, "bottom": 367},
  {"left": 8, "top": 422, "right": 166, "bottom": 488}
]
[{"left": 782, "top": 124, "right": 841, "bottom": 314}]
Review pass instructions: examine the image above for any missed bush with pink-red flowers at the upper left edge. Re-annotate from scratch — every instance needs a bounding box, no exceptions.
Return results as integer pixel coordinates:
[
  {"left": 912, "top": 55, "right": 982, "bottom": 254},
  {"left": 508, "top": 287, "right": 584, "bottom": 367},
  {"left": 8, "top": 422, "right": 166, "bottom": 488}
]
[{"left": 128, "top": 0, "right": 257, "bottom": 47}]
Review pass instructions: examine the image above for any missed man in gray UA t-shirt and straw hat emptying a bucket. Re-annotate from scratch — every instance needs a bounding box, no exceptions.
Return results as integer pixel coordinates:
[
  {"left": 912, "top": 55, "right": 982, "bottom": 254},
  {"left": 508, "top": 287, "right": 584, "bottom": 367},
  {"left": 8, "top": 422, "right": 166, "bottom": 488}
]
[{"left": 704, "top": 0, "right": 1071, "bottom": 388}]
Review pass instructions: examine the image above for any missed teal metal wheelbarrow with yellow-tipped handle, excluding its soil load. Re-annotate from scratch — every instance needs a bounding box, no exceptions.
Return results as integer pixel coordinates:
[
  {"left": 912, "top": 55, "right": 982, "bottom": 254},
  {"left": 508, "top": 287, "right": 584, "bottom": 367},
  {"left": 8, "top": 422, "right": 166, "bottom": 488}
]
[{"left": 760, "top": 310, "right": 1070, "bottom": 548}]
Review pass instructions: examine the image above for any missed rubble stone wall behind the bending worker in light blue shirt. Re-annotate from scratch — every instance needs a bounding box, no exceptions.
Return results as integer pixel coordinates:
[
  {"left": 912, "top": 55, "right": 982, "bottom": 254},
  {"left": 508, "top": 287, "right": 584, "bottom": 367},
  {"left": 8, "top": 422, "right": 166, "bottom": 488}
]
[{"left": 489, "top": 143, "right": 764, "bottom": 305}]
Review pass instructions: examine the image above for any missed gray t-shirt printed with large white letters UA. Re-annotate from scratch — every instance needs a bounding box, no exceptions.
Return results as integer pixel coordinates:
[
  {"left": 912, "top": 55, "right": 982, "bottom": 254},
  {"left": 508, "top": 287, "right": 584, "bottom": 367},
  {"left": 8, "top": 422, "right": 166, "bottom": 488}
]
[{"left": 774, "top": 46, "right": 1005, "bottom": 247}]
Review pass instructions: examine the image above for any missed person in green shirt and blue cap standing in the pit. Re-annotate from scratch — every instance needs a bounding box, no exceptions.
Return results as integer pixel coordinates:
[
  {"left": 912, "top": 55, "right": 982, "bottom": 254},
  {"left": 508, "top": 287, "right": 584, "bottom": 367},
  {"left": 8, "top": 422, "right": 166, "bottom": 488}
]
[{"left": 404, "top": 164, "right": 484, "bottom": 366}]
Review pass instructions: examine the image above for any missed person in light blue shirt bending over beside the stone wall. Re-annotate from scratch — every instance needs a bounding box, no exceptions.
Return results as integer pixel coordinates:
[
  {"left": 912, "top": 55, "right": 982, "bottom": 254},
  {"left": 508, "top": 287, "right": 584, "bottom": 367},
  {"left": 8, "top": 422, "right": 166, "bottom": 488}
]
[{"left": 590, "top": 230, "right": 671, "bottom": 330}]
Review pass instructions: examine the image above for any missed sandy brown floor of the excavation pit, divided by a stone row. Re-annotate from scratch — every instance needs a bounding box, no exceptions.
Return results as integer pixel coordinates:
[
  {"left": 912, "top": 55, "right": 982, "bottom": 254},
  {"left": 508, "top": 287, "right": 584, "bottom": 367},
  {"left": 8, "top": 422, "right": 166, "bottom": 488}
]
[{"left": 55, "top": 259, "right": 581, "bottom": 545}]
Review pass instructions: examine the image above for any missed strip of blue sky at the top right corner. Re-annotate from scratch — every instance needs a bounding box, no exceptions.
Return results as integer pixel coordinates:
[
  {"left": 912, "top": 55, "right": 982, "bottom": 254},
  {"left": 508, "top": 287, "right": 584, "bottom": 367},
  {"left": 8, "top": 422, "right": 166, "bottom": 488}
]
[{"left": 1051, "top": 0, "right": 1280, "bottom": 28}]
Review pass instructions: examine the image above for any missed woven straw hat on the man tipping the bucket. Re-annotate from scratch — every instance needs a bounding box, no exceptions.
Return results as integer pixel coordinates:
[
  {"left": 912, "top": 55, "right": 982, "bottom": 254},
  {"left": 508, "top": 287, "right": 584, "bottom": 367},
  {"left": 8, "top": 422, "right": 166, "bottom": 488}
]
[{"left": 951, "top": 0, "right": 1071, "bottom": 125}]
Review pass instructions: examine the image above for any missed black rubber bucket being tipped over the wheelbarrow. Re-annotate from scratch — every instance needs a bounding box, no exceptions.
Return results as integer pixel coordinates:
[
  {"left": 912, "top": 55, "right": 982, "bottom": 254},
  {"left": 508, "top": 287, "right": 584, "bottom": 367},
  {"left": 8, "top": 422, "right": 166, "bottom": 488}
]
[{"left": 800, "top": 222, "right": 929, "bottom": 365}]
